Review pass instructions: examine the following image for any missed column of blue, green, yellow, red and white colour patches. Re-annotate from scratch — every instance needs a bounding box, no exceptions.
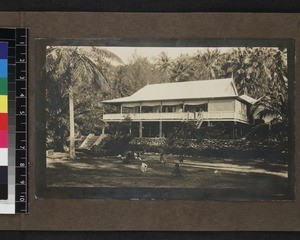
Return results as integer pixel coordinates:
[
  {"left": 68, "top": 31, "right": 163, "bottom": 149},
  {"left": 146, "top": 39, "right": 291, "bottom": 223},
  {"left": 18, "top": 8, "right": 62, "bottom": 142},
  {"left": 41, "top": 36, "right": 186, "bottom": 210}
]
[{"left": 0, "top": 42, "right": 8, "bottom": 199}]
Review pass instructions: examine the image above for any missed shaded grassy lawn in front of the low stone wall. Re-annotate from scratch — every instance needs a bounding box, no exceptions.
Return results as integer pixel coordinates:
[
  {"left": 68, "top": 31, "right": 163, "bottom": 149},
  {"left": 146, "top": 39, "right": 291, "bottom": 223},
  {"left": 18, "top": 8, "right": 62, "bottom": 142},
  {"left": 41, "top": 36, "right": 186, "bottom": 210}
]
[{"left": 47, "top": 153, "right": 288, "bottom": 200}]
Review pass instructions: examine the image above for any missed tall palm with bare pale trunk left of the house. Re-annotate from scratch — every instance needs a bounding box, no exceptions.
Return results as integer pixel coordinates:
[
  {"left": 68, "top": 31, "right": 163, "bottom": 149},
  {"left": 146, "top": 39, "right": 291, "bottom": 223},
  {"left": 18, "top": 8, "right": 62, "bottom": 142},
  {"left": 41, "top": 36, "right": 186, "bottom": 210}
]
[{"left": 45, "top": 46, "right": 121, "bottom": 159}]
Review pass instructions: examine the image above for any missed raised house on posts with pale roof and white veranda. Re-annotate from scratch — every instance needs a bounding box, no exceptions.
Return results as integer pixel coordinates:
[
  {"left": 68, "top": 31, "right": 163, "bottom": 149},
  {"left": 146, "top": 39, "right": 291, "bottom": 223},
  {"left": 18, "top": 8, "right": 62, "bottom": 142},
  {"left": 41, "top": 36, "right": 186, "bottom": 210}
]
[{"left": 103, "top": 78, "right": 257, "bottom": 138}]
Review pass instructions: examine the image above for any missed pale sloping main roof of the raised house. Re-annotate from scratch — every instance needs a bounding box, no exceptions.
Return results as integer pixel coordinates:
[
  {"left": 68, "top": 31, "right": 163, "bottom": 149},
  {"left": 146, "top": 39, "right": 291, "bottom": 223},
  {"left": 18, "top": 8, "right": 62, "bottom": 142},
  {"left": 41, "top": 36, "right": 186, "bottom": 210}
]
[{"left": 103, "top": 78, "right": 238, "bottom": 103}]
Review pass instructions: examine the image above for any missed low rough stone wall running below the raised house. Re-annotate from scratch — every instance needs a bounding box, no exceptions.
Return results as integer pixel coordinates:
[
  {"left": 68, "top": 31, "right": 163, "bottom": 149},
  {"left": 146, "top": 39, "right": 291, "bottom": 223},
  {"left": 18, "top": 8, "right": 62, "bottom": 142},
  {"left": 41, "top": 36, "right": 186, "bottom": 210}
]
[{"left": 130, "top": 139, "right": 288, "bottom": 161}]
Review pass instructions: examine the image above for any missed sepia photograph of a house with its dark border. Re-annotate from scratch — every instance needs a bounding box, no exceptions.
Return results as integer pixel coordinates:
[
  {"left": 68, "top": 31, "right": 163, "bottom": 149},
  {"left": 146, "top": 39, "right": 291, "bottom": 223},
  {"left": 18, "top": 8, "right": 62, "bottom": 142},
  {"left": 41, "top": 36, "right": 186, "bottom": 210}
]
[{"left": 36, "top": 39, "right": 295, "bottom": 201}]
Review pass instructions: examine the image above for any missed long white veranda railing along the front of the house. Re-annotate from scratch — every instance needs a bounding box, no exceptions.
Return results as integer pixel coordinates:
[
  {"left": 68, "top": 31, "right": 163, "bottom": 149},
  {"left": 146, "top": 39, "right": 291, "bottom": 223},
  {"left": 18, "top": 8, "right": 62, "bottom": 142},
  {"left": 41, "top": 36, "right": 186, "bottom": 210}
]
[{"left": 103, "top": 111, "right": 248, "bottom": 122}]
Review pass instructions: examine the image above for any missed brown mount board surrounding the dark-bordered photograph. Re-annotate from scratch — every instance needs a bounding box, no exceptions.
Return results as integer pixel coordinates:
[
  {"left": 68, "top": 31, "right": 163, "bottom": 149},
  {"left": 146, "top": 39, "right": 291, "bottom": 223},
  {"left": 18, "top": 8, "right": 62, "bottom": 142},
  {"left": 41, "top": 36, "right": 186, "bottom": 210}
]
[{"left": 0, "top": 12, "right": 300, "bottom": 231}]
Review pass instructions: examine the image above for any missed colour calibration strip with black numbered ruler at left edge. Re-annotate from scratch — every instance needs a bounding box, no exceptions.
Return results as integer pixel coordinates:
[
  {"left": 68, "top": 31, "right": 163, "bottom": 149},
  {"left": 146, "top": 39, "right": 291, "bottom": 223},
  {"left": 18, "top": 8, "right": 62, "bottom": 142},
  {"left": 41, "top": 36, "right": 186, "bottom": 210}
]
[{"left": 0, "top": 28, "right": 28, "bottom": 214}]
